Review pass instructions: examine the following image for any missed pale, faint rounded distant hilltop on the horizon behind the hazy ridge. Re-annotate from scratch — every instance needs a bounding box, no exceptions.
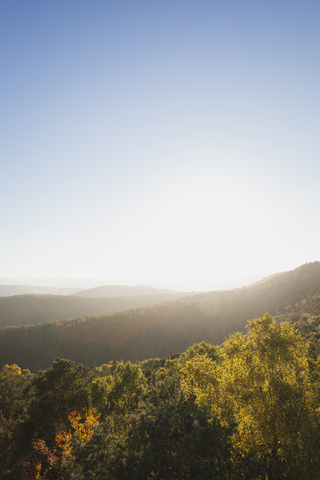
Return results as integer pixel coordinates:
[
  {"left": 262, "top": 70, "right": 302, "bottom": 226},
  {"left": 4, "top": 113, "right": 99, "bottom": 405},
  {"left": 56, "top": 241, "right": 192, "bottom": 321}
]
[{"left": 73, "top": 285, "right": 182, "bottom": 298}]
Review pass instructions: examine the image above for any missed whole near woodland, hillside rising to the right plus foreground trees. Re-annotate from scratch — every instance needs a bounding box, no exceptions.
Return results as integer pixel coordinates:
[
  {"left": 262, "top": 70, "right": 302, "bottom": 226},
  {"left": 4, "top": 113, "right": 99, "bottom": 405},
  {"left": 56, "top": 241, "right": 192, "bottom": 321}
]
[{"left": 0, "top": 262, "right": 320, "bottom": 480}]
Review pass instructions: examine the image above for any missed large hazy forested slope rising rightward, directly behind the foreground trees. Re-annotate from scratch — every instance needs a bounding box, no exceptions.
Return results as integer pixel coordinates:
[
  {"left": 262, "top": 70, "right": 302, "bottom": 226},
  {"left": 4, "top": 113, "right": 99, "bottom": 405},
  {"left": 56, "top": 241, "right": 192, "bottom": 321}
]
[{"left": 0, "top": 262, "right": 320, "bottom": 371}]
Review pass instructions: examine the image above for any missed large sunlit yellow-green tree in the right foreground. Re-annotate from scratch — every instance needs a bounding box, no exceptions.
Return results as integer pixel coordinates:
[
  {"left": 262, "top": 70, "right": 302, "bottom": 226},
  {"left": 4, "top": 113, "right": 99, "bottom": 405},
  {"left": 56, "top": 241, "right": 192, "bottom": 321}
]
[{"left": 183, "top": 314, "right": 318, "bottom": 480}]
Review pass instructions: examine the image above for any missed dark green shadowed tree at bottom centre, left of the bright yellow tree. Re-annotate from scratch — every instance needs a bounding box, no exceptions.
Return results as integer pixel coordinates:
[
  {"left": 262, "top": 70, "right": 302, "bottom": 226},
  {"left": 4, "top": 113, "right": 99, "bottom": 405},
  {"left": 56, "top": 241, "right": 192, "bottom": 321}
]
[{"left": 60, "top": 378, "right": 231, "bottom": 480}]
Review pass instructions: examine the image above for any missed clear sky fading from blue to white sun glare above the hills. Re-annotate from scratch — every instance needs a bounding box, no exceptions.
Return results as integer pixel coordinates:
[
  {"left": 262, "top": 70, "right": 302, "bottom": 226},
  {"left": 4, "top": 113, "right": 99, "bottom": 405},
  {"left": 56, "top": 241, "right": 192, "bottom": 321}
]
[{"left": 0, "top": 0, "right": 320, "bottom": 290}]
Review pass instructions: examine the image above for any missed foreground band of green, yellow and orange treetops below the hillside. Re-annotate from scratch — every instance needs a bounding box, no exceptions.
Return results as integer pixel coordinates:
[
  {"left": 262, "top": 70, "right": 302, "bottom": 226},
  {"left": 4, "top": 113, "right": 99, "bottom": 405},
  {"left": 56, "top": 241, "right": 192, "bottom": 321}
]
[{"left": 0, "top": 314, "right": 320, "bottom": 480}]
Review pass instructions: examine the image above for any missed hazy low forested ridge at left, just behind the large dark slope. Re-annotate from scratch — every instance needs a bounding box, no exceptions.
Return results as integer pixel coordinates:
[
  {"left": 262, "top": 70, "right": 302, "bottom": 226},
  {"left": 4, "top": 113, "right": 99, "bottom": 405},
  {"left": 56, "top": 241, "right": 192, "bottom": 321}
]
[{"left": 0, "top": 292, "right": 185, "bottom": 328}]
